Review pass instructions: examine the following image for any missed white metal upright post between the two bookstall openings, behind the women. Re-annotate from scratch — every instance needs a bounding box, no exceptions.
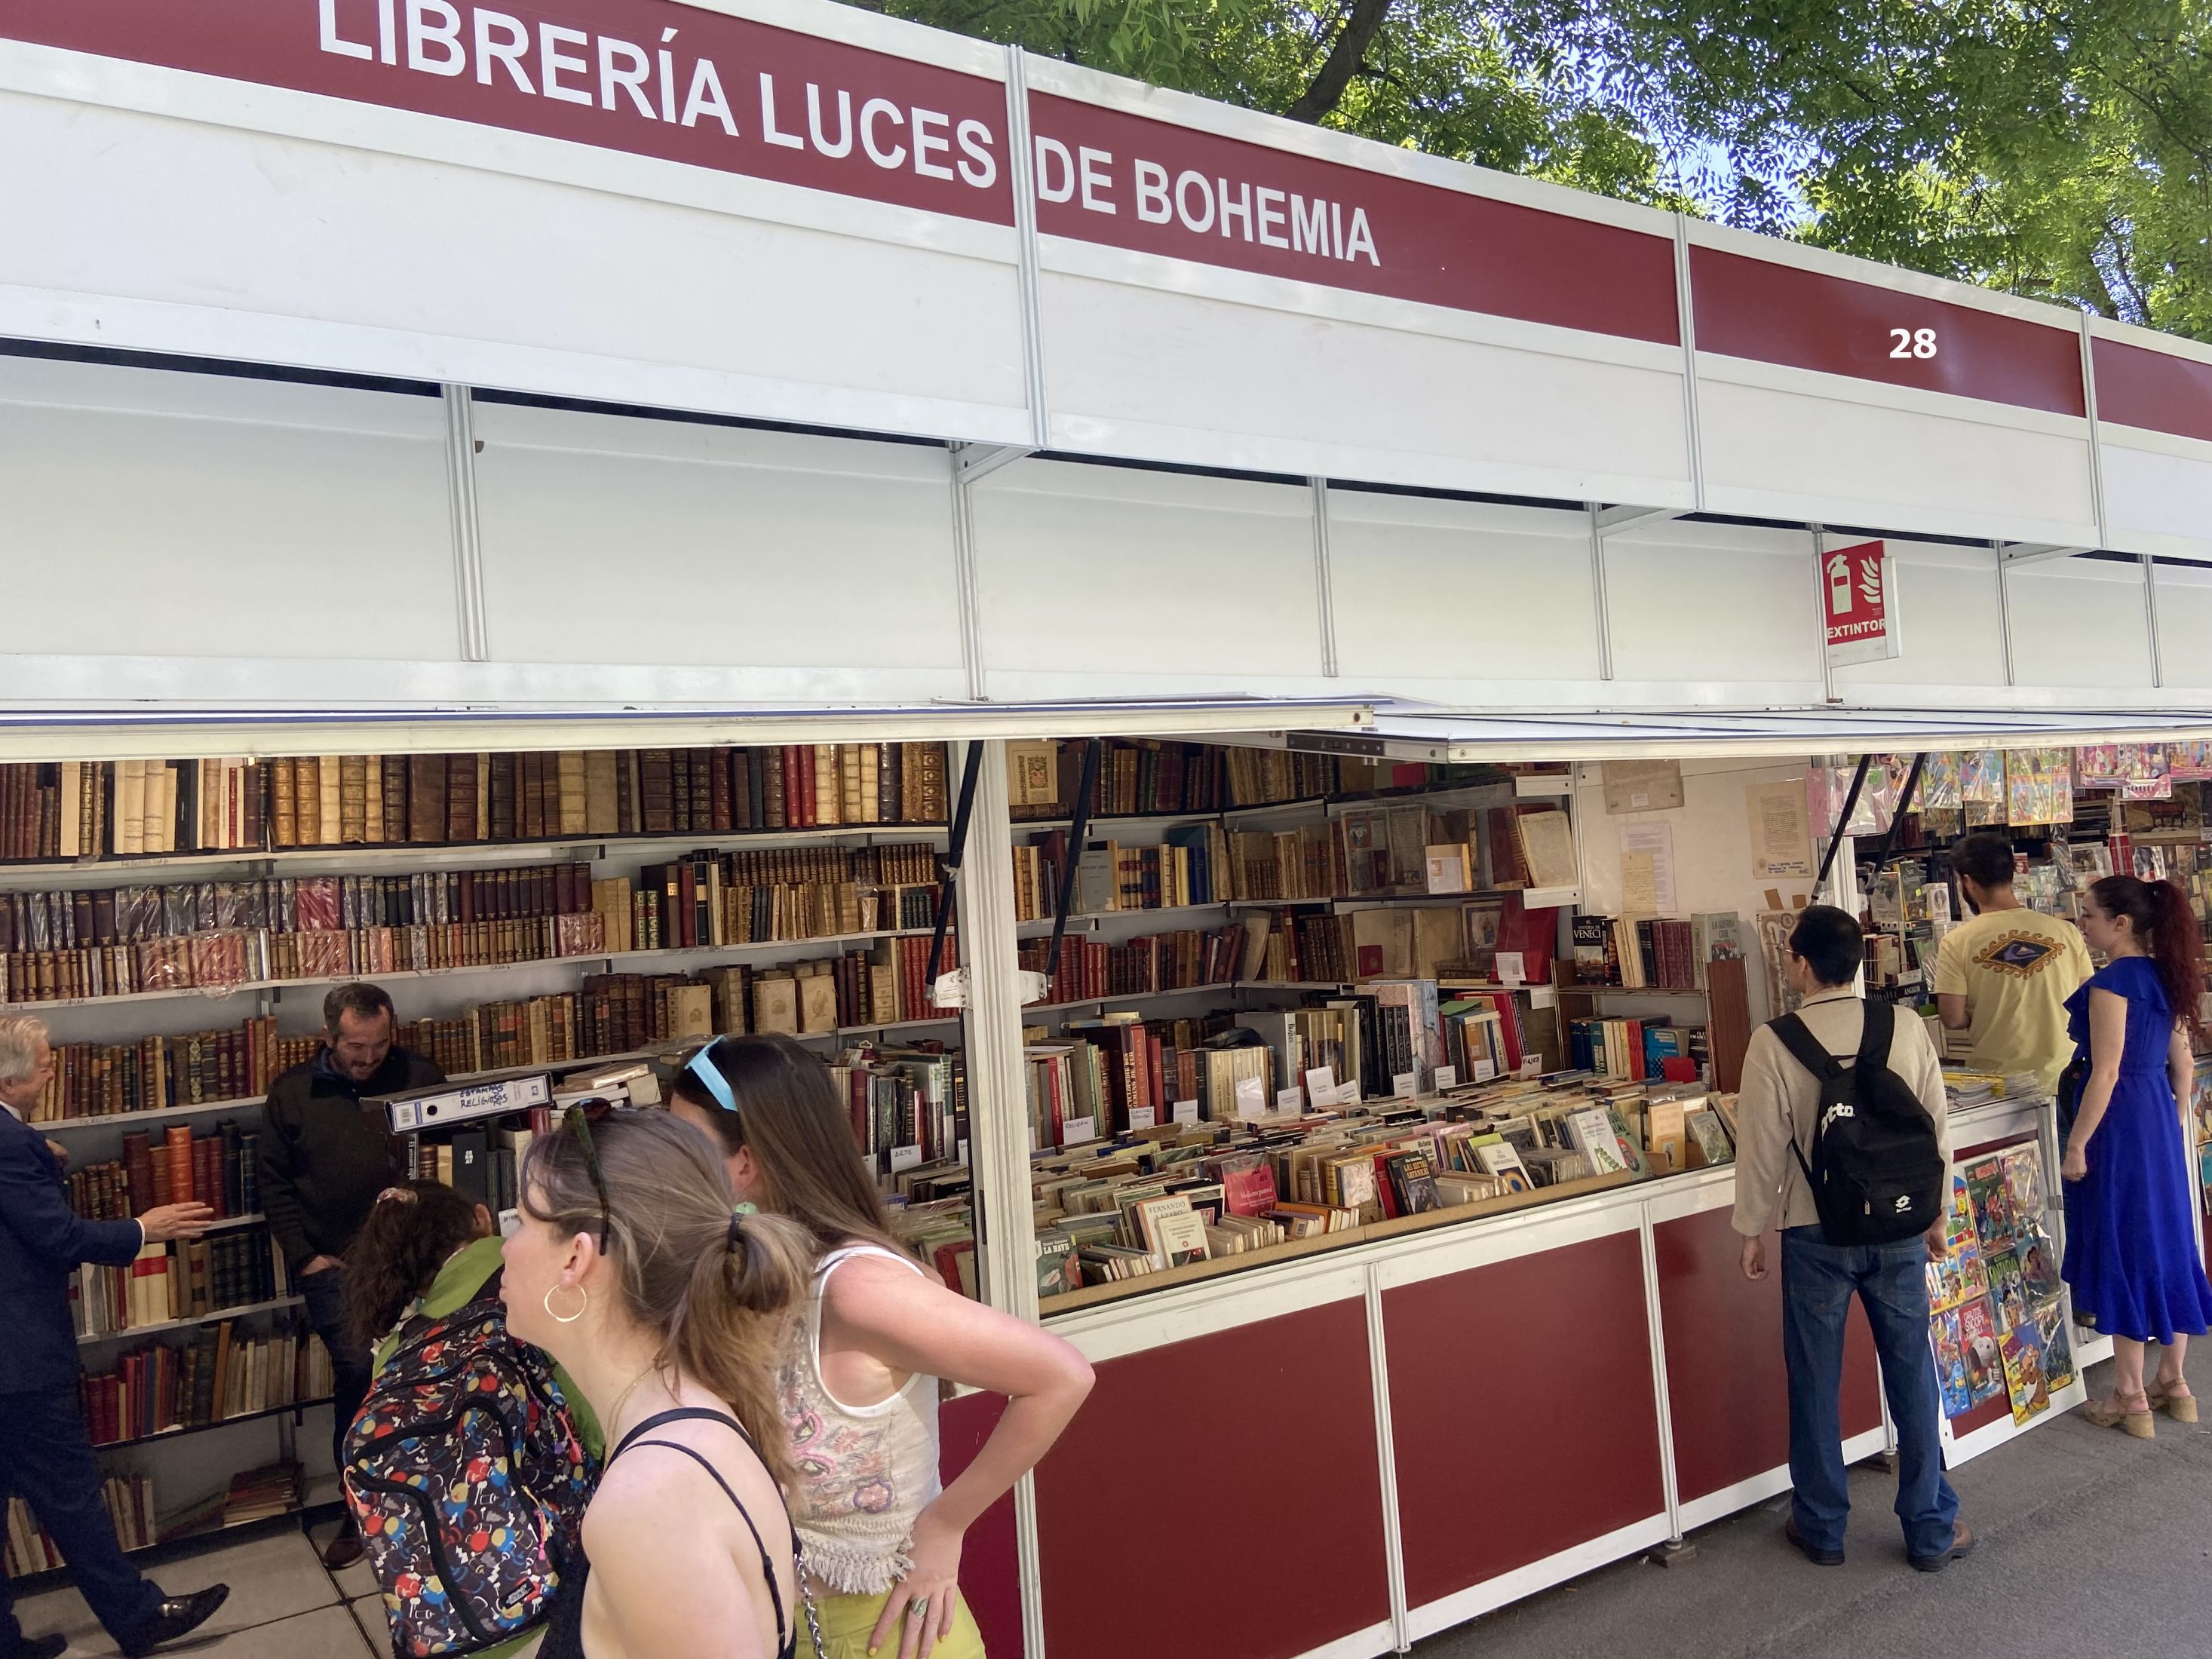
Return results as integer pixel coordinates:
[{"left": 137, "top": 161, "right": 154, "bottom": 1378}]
[{"left": 958, "top": 739, "right": 1044, "bottom": 1659}]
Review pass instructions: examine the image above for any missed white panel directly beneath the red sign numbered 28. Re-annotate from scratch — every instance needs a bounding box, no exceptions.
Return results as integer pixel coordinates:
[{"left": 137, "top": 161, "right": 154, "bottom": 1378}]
[{"left": 1697, "top": 365, "right": 2097, "bottom": 547}]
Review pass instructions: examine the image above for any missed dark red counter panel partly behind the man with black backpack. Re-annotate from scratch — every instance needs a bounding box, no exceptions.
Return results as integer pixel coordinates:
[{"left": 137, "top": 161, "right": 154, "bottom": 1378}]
[{"left": 1652, "top": 1210, "right": 1882, "bottom": 1504}]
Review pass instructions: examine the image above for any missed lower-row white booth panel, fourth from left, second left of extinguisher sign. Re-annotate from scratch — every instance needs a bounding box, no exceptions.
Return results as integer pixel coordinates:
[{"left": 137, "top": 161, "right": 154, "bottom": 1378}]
[{"left": 1330, "top": 486, "right": 1601, "bottom": 701}]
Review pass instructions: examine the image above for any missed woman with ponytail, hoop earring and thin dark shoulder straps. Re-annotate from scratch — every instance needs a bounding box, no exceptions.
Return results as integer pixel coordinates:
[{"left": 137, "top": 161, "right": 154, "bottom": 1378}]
[{"left": 502, "top": 1109, "right": 808, "bottom": 1659}]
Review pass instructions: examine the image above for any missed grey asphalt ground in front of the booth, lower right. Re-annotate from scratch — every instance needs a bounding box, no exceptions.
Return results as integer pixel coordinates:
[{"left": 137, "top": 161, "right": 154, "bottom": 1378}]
[{"left": 1416, "top": 1354, "right": 2212, "bottom": 1659}]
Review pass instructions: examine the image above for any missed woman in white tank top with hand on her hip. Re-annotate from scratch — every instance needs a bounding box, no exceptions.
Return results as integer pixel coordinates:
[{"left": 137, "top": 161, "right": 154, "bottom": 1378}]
[{"left": 670, "top": 1038, "right": 1091, "bottom": 1659}]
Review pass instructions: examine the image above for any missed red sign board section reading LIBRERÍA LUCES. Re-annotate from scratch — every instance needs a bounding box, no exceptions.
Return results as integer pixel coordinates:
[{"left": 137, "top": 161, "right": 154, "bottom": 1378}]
[{"left": 0, "top": 0, "right": 1013, "bottom": 225}]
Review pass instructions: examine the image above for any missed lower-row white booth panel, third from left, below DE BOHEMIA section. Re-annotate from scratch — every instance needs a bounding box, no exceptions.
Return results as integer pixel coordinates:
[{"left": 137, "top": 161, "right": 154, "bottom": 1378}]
[{"left": 971, "top": 460, "right": 1321, "bottom": 697}]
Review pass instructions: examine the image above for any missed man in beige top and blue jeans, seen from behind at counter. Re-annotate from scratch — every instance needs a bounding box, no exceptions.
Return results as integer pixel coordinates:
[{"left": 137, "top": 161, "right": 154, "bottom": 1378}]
[{"left": 1734, "top": 905, "right": 1973, "bottom": 1573}]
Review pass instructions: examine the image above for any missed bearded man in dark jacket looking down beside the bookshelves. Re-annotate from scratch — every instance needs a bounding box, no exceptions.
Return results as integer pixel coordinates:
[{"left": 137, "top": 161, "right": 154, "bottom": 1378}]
[{"left": 261, "top": 984, "right": 445, "bottom": 1571}]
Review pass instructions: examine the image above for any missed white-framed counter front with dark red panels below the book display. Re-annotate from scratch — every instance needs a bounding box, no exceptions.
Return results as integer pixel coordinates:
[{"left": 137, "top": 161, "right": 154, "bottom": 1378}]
[{"left": 1004, "top": 1102, "right": 2070, "bottom": 1659}]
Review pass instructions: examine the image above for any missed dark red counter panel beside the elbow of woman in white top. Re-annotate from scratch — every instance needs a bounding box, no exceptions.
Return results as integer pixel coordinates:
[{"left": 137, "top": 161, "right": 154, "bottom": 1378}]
[{"left": 1030, "top": 1299, "right": 1380, "bottom": 1659}]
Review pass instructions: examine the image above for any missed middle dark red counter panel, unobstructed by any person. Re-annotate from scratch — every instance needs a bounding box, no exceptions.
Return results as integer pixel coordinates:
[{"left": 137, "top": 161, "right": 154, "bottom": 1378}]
[{"left": 1380, "top": 1232, "right": 1666, "bottom": 1610}]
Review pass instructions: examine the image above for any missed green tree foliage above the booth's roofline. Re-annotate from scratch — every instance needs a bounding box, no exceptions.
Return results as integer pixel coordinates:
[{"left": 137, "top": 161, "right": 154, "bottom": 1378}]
[{"left": 885, "top": 0, "right": 2212, "bottom": 339}]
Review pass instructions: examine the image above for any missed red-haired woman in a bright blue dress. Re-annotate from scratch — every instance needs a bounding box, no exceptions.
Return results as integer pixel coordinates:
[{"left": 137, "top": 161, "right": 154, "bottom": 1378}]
[{"left": 2060, "top": 876, "right": 2212, "bottom": 1440}]
